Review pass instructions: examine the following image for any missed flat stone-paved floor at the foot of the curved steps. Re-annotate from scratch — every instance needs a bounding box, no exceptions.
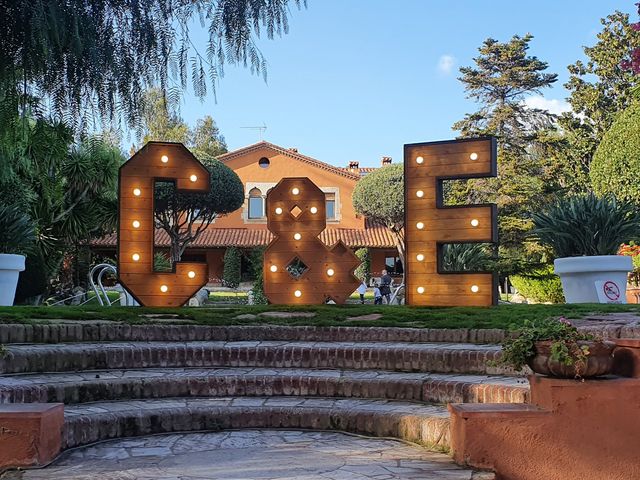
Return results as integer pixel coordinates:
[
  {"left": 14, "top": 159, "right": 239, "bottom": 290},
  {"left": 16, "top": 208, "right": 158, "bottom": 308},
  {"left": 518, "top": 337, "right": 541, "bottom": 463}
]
[{"left": 7, "top": 430, "right": 486, "bottom": 480}]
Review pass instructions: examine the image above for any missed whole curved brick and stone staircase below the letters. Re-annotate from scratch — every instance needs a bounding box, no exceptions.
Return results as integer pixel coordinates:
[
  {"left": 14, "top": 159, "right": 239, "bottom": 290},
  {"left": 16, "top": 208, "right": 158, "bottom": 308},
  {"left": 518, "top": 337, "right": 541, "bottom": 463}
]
[{"left": 0, "top": 321, "right": 529, "bottom": 468}]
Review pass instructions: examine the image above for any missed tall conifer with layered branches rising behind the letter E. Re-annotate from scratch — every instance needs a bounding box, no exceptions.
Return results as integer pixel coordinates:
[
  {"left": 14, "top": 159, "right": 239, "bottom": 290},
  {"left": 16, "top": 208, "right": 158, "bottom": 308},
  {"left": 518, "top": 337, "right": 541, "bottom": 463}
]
[{"left": 446, "top": 35, "right": 557, "bottom": 273}]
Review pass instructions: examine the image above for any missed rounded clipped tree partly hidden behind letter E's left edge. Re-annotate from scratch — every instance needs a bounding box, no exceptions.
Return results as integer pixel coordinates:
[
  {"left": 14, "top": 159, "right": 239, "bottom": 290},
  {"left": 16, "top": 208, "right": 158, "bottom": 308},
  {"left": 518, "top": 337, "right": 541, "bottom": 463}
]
[{"left": 353, "top": 164, "right": 404, "bottom": 264}]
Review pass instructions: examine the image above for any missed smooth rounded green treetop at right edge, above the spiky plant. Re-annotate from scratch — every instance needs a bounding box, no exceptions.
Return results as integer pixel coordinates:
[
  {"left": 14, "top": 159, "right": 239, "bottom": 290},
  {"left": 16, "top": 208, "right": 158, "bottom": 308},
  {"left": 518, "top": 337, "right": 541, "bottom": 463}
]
[{"left": 590, "top": 102, "right": 640, "bottom": 202}]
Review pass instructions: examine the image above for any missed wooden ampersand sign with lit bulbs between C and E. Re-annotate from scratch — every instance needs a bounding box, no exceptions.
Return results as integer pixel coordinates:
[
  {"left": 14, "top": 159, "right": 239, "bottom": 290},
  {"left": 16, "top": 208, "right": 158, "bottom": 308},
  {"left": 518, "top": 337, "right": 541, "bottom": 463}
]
[{"left": 264, "top": 178, "right": 360, "bottom": 305}]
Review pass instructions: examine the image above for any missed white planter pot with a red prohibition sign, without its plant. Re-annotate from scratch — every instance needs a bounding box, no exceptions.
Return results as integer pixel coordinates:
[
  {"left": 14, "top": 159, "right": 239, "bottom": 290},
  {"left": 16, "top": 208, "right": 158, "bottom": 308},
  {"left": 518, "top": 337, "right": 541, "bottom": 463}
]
[{"left": 553, "top": 255, "right": 633, "bottom": 303}]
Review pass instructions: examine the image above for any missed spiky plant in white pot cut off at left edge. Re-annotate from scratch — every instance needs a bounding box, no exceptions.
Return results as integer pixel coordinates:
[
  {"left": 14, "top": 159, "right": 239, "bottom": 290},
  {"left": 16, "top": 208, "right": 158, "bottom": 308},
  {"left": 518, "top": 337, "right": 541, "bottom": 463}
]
[{"left": 0, "top": 206, "right": 35, "bottom": 306}]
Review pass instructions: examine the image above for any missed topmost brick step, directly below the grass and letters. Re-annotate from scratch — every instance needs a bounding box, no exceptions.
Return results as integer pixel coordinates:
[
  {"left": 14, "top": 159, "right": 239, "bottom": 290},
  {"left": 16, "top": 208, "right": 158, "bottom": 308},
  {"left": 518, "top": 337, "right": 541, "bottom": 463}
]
[{"left": 0, "top": 319, "right": 505, "bottom": 344}]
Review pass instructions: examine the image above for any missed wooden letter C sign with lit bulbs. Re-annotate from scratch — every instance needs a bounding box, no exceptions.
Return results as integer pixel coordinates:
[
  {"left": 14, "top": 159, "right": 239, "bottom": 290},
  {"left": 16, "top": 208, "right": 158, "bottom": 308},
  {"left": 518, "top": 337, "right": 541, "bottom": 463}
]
[{"left": 118, "top": 142, "right": 209, "bottom": 307}]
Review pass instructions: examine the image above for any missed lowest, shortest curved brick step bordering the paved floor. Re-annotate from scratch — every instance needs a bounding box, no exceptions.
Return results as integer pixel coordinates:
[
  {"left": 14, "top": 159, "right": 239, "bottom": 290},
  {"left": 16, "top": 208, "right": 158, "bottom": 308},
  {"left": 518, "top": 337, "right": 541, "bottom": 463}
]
[{"left": 63, "top": 397, "right": 449, "bottom": 449}]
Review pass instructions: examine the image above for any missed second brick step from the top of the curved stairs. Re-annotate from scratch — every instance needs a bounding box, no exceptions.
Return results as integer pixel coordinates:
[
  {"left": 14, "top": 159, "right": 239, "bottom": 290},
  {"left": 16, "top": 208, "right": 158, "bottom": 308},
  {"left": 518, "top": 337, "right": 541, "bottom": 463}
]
[{"left": 0, "top": 341, "right": 512, "bottom": 375}]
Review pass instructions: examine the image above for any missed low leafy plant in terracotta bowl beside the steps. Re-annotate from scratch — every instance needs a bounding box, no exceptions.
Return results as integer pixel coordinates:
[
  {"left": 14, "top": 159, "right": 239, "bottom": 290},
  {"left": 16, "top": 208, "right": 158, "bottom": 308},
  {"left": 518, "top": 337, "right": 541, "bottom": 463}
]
[{"left": 499, "top": 318, "right": 615, "bottom": 378}]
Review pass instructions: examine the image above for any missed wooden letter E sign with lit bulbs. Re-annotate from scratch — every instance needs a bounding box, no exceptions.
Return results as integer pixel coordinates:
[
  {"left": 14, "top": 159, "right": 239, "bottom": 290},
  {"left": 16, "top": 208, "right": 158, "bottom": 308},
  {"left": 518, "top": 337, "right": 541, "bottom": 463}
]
[{"left": 404, "top": 137, "right": 498, "bottom": 306}]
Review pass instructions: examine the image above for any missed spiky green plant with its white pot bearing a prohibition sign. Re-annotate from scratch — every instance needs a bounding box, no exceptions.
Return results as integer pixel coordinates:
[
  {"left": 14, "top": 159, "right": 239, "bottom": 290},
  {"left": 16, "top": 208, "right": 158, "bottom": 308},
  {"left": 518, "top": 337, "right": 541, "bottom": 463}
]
[{"left": 532, "top": 194, "right": 640, "bottom": 303}]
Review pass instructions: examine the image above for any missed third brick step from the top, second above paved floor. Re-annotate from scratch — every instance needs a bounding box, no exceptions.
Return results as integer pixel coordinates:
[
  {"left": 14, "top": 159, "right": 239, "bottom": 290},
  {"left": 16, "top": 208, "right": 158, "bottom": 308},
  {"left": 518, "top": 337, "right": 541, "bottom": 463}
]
[{"left": 0, "top": 368, "right": 529, "bottom": 404}]
